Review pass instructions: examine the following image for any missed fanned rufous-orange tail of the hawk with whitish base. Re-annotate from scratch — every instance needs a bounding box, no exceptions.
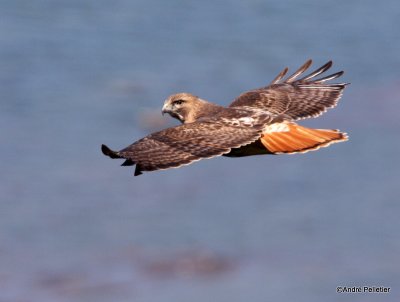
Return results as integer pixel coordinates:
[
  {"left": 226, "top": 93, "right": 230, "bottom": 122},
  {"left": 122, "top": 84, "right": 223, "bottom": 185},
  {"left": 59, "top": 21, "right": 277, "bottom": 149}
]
[{"left": 261, "top": 123, "right": 348, "bottom": 154}]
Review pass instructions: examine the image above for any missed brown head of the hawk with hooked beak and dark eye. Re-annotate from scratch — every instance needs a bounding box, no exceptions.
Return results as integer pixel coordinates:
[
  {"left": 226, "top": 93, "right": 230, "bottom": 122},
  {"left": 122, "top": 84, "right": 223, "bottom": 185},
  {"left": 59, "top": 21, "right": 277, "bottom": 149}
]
[{"left": 161, "top": 93, "right": 207, "bottom": 123}]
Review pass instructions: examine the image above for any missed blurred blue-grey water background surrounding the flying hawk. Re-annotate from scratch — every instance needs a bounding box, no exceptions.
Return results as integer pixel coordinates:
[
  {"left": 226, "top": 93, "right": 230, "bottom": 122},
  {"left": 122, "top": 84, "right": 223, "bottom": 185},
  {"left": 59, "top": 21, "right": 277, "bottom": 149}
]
[{"left": 0, "top": 0, "right": 400, "bottom": 302}]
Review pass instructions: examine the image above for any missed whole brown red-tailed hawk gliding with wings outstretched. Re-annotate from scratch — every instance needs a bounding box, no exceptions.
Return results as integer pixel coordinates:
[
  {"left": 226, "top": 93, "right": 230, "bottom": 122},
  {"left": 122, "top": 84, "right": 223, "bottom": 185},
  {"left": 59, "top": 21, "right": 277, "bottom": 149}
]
[{"left": 101, "top": 60, "right": 347, "bottom": 176}]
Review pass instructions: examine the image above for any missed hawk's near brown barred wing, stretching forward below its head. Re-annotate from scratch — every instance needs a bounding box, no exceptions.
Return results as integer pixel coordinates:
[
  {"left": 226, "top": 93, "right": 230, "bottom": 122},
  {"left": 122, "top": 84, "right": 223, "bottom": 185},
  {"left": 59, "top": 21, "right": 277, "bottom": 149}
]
[{"left": 102, "top": 122, "right": 261, "bottom": 176}]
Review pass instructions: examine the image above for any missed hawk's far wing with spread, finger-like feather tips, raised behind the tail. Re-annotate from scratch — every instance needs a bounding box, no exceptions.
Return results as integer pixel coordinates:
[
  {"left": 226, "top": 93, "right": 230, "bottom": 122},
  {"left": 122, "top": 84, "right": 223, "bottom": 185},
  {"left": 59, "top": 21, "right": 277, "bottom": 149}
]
[{"left": 229, "top": 60, "right": 347, "bottom": 120}]
